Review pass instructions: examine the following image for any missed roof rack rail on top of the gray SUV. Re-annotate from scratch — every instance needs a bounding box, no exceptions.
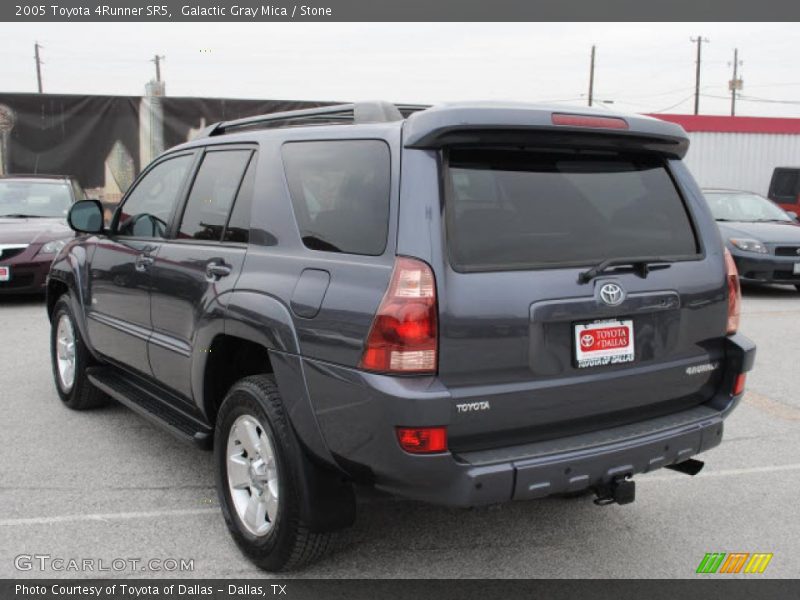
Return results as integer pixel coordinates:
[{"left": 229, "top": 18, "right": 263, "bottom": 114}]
[{"left": 198, "top": 101, "right": 428, "bottom": 137}]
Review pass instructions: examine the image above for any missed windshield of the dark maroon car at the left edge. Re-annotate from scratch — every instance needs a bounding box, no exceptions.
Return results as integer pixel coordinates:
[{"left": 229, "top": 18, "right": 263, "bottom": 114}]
[{"left": 0, "top": 180, "right": 72, "bottom": 218}]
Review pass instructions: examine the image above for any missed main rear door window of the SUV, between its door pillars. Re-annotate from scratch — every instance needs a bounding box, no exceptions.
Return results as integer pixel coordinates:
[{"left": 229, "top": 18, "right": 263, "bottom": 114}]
[{"left": 178, "top": 150, "right": 252, "bottom": 241}]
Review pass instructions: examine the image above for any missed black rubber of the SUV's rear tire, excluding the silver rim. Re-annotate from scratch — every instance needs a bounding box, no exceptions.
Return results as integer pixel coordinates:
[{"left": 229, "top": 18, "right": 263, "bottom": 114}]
[{"left": 214, "top": 375, "right": 334, "bottom": 572}]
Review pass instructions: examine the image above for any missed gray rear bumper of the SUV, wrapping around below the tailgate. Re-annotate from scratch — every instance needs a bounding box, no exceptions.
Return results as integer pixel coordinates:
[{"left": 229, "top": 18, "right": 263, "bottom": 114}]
[{"left": 304, "top": 335, "right": 755, "bottom": 506}]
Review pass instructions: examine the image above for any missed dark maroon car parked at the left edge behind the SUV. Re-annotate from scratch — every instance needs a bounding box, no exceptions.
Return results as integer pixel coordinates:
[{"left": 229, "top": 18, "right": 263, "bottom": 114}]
[{"left": 0, "top": 175, "right": 85, "bottom": 294}]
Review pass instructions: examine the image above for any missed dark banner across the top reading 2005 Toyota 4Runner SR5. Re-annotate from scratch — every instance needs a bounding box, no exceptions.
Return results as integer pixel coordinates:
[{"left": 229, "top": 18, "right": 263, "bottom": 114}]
[{"left": 0, "top": 0, "right": 800, "bottom": 22}]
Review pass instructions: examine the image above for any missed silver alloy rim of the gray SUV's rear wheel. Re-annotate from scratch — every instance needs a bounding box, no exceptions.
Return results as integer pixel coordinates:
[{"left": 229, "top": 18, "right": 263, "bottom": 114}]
[{"left": 226, "top": 415, "right": 279, "bottom": 537}]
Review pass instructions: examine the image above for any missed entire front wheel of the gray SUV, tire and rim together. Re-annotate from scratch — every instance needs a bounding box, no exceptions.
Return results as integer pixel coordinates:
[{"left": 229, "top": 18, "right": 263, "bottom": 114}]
[{"left": 50, "top": 296, "right": 108, "bottom": 410}]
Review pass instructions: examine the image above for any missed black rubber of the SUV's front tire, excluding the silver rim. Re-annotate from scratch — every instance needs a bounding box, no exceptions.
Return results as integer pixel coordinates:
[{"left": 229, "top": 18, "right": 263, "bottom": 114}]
[{"left": 50, "top": 296, "right": 108, "bottom": 410}]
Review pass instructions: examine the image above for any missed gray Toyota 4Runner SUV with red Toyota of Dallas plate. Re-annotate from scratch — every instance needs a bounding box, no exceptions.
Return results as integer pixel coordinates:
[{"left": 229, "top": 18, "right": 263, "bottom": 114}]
[{"left": 47, "top": 103, "right": 755, "bottom": 570}]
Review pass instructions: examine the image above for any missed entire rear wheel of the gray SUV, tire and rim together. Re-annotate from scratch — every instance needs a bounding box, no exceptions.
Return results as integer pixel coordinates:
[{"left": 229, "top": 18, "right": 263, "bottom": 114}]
[{"left": 214, "top": 375, "right": 333, "bottom": 572}]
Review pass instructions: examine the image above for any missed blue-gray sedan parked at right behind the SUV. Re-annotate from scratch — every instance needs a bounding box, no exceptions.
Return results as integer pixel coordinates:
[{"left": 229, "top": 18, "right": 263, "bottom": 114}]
[{"left": 703, "top": 189, "right": 800, "bottom": 291}]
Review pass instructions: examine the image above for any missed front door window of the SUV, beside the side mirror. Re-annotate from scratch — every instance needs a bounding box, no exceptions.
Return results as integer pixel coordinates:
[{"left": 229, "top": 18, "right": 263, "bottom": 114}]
[{"left": 117, "top": 154, "right": 193, "bottom": 238}]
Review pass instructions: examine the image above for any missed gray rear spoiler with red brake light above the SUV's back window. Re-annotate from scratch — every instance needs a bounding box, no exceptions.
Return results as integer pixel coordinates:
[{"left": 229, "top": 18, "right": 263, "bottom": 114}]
[{"left": 403, "top": 103, "right": 689, "bottom": 158}]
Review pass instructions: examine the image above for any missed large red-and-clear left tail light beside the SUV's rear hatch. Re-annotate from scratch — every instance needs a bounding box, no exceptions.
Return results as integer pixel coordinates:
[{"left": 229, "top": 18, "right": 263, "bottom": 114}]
[{"left": 359, "top": 256, "right": 438, "bottom": 373}]
